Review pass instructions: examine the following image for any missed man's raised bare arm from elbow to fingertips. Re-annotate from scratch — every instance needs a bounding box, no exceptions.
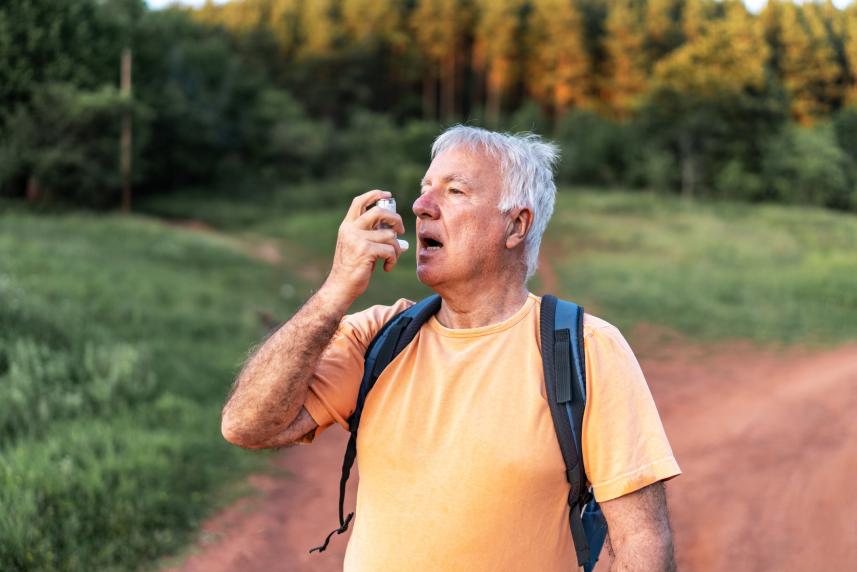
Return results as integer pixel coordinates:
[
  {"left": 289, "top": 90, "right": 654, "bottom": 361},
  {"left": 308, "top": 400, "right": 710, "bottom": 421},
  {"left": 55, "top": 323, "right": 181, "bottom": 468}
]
[{"left": 221, "top": 191, "right": 405, "bottom": 449}]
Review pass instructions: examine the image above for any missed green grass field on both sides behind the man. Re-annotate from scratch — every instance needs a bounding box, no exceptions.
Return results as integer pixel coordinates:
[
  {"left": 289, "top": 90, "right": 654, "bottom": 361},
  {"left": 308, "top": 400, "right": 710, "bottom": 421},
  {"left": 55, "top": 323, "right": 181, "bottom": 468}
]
[{"left": 0, "top": 191, "right": 857, "bottom": 570}]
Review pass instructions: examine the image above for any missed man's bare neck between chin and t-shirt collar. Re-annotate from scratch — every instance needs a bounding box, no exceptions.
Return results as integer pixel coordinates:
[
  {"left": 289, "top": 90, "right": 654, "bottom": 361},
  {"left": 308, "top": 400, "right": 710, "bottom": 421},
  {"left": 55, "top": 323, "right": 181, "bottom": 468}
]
[{"left": 437, "top": 274, "right": 529, "bottom": 329}]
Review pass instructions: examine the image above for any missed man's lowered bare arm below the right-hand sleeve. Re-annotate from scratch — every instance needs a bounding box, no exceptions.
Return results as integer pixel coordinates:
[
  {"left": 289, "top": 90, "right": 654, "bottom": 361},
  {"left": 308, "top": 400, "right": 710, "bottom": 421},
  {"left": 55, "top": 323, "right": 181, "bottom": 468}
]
[{"left": 600, "top": 482, "right": 675, "bottom": 572}]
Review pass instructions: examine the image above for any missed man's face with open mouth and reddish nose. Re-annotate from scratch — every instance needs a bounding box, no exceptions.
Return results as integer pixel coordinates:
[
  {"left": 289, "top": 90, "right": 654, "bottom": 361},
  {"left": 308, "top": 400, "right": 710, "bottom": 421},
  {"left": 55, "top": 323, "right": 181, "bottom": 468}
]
[{"left": 413, "top": 147, "right": 507, "bottom": 290}]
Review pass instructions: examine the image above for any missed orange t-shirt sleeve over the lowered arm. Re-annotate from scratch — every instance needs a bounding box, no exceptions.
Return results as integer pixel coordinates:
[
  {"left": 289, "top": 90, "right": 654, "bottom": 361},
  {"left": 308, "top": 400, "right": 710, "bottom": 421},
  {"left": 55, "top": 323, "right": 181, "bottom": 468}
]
[{"left": 583, "top": 321, "right": 681, "bottom": 502}]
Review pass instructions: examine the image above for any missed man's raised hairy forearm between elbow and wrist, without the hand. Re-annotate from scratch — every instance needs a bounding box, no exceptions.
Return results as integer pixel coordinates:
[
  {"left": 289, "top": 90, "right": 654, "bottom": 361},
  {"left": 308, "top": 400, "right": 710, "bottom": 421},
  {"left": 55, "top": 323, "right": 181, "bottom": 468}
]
[{"left": 222, "top": 287, "right": 349, "bottom": 447}]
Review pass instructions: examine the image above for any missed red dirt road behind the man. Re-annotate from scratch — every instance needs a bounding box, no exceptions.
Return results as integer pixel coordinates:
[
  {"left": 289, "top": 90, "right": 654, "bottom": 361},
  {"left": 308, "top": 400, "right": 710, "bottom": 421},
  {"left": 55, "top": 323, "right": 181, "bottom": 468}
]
[{"left": 166, "top": 338, "right": 857, "bottom": 572}]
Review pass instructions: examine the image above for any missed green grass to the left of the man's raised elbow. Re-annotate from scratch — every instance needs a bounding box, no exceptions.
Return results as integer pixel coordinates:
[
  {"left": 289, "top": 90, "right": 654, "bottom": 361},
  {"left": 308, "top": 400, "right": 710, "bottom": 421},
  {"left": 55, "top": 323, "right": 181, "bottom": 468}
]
[{"left": 0, "top": 210, "right": 298, "bottom": 570}]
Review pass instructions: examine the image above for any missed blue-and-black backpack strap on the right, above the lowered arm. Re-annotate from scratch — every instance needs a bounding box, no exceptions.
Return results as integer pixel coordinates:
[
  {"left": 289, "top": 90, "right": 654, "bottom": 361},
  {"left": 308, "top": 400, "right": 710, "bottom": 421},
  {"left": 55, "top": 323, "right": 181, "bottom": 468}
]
[{"left": 540, "top": 295, "right": 592, "bottom": 566}]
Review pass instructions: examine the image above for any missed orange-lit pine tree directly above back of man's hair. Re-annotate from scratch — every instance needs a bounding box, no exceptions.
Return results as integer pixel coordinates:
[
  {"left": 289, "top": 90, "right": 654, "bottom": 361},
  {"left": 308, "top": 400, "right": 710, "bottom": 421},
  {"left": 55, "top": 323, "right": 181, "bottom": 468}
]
[{"left": 525, "top": 0, "right": 592, "bottom": 115}]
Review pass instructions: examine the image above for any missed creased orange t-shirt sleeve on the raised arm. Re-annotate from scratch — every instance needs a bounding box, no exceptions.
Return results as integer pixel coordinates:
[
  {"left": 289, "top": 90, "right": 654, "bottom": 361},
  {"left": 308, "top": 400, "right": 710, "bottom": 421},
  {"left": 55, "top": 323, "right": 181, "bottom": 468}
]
[{"left": 304, "top": 299, "right": 413, "bottom": 435}]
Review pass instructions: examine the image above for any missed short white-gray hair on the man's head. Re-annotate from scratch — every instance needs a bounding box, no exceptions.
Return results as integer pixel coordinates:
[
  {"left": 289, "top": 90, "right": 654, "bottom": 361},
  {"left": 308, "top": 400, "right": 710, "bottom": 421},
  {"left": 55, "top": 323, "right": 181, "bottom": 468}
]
[{"left": 431, "top": 125, "right": 559, "bottom": 280}]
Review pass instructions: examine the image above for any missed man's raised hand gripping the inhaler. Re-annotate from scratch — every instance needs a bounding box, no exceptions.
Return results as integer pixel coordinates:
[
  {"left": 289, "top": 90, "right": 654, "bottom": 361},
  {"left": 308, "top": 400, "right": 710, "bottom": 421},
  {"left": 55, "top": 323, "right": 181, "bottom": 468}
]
[{"left": 323, "top": 190, "right": 405, "bottom": 305}]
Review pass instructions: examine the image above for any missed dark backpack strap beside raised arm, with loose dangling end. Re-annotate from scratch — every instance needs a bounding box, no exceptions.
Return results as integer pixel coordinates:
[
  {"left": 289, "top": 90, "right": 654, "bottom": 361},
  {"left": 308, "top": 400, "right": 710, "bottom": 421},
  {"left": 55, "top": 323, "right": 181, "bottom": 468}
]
[{"left": 310, "top": 294, "right": 441, "bottom": 553}]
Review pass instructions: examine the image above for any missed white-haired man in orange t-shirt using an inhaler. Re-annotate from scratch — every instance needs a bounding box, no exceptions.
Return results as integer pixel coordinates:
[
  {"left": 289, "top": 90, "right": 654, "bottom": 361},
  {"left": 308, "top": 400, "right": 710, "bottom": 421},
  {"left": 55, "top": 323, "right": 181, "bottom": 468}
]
[{"left": 223, "top": 126, "right": 680, "bottom": 572}]
